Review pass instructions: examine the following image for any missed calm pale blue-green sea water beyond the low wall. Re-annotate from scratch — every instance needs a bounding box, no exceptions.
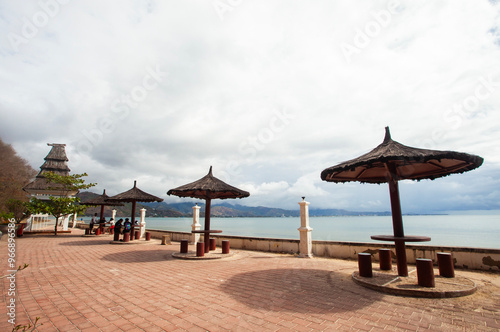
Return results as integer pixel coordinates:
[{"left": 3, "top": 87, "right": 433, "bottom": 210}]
[{"left": 137, "top": 211, "right": 500, "bottom": 249}]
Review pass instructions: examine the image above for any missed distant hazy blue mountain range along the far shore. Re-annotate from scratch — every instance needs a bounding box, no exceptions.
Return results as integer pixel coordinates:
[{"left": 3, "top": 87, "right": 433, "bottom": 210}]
[{"left": 77, "top": 192, "right": 391, "bottom": 217}]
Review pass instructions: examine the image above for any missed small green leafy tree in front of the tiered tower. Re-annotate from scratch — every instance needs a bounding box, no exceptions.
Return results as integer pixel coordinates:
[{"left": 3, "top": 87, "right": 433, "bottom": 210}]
[{"left": 26, "top": 172, "right": 96, "bottom": 235}]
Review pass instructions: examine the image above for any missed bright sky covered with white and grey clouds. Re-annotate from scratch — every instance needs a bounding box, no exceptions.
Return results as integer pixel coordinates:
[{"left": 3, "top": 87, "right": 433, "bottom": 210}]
[{"left": 0, "top": 0, "right": 500, "bottom": 212}]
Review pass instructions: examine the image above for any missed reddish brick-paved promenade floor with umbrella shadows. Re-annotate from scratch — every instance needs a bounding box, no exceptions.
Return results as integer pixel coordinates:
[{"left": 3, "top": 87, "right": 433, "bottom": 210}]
[{"left": 0, "top": 229, "right": 500, "bottom": 331}]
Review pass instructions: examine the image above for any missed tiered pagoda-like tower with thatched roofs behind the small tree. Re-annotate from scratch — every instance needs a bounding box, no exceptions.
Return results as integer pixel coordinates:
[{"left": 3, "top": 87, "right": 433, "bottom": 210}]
[{"left": 23, "top": 143, "right": 78, "bottom": 230}]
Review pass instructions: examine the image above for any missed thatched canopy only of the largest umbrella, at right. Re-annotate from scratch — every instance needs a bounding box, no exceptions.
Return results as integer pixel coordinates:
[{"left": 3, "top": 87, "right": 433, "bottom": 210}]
[{"left": 321, "top": 127, "right": 483, "bottom": 183}]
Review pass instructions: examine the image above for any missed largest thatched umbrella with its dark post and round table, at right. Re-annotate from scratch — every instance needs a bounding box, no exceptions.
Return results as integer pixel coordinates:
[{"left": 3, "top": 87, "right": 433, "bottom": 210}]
[{"left": 321, "top": 127, "right": 483, "bottom": 276}]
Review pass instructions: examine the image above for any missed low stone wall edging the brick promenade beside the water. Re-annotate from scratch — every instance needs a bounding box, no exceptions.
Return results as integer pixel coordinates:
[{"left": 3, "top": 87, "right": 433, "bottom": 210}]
[{"left": 147, "top": 230, "right": 500, "bottom": 271}]
